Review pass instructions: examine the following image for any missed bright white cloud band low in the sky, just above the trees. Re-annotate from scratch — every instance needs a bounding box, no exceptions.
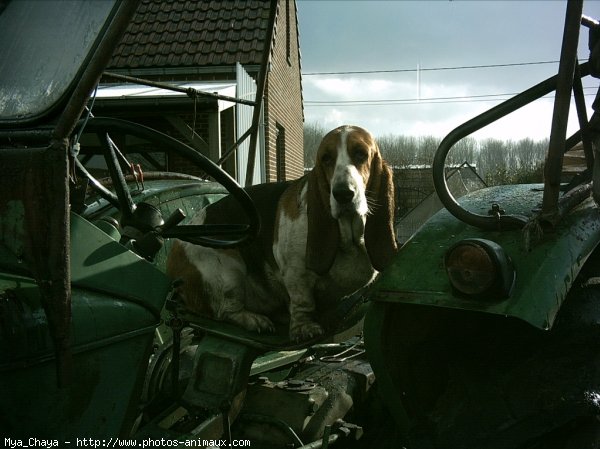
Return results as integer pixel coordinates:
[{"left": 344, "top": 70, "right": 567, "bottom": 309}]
[{"left": 304, "top": 75, "right": 591, "bottom": 140}]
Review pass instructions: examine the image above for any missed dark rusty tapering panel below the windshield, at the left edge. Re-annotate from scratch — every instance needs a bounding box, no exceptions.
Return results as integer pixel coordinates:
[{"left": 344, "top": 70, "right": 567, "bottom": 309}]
[{"left": 0, "top": 144, "right": 71, "bottom": 385}]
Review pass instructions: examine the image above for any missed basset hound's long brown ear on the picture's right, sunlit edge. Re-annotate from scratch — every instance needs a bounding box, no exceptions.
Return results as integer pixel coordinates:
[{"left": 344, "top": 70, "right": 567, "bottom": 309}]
[{"left": 365, "top": 150, "right": 398, "bottom": 271}]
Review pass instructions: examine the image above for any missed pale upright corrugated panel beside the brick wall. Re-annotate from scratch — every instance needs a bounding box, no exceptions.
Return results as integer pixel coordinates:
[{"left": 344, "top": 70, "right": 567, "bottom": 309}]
[{"left": 236, "top": 63, "right": 266, "bottom": 184}]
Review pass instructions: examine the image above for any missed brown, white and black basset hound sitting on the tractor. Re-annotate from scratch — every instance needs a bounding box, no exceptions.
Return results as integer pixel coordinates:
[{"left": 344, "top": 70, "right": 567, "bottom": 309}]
[{"left": 167, "top": 126, "right": 397, "bottom": 341}]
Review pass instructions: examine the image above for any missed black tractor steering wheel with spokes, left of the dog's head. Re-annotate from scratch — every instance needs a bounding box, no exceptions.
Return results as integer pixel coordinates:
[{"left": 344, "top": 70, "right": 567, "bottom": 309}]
[{"left": 74, "top": 117, "right": 260, "bottom": 248}]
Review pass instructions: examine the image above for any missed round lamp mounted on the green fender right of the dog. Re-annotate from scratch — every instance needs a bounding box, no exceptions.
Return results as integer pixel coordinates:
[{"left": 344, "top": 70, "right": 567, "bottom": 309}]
[{"left": 445, "top": 239, "right": 515, "bottom": 299}]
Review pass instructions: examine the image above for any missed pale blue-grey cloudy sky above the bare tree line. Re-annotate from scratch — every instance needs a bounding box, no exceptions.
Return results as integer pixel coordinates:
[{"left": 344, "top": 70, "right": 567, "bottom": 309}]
[{"left": 297, "top": 0, "right": 600, "bottom": 140}]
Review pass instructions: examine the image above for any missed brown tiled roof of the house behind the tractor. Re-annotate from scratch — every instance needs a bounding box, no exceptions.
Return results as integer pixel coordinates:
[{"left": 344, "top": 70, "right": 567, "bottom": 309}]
[{"left": 108, "top": 0, "right": 269, "bottom": 69}]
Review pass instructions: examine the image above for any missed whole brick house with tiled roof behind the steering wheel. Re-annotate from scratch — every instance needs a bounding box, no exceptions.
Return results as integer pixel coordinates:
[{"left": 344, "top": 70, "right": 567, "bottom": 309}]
[{"left": 101, "top": 0, "right": 304, "bottom": 183}]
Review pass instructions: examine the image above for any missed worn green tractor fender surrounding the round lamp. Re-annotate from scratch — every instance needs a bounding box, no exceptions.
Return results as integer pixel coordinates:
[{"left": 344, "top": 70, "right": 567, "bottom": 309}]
[{"left": 372, "top": 185, "right": 600, "bottom": 329}]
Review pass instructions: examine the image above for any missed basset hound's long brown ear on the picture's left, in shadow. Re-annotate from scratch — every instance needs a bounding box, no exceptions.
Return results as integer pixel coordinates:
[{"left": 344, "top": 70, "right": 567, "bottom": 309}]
[{"left": 306, "top": 162, "right": 340, "bottom": 275}]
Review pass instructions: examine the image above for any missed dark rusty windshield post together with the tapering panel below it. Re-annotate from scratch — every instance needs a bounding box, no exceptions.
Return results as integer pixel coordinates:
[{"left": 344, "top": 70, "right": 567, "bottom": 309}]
[{"left": 0, "top": 0, "right": 143, "bottom": 386}]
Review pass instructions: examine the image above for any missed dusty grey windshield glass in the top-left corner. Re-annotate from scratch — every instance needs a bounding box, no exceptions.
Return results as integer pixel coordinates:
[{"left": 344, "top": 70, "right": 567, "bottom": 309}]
[{"left": 0, "top": 0, "right": 121, "bottom": 128}]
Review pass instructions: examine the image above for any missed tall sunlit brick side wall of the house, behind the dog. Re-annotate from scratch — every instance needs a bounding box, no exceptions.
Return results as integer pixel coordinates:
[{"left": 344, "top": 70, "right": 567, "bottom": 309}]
[{"left": 265, "top": 0, "right": 304, "bottom": 182}]
